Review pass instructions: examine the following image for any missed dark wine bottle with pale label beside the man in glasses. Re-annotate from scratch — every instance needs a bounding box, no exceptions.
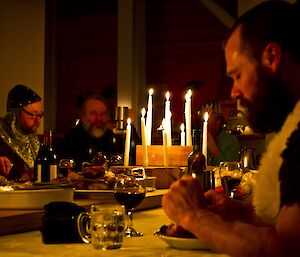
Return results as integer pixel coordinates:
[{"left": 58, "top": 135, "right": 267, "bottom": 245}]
[{"left": 34, "top": 131, "right": 58, "bottom": 182}]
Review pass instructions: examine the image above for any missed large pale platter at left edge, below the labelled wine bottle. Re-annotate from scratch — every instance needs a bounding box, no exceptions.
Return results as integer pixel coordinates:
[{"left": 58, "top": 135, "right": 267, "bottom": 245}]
[{"left": 0, "top": 188, "right": 74, "bottom": 209}]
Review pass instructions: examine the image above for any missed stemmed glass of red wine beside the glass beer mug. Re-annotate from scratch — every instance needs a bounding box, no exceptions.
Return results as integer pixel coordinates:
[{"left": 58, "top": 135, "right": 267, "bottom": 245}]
[{"left": 114, "top": 174, "right": 146, "bottom": 237}]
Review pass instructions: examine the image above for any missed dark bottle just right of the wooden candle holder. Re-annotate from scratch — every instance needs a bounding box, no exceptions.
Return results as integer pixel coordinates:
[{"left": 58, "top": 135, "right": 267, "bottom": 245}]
[{"left": 188, "top": 129, "right": 206, "bottom": 177}]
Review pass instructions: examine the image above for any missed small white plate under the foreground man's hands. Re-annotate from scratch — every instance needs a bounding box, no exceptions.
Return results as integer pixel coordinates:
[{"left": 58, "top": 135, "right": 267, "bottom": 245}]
[{"left": 154, "top": 232, "right": 209, "bottom": 250}]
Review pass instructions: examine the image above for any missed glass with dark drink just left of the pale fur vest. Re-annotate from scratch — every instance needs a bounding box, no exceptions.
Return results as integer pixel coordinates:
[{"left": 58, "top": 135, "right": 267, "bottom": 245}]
[{"left": 219, "top": 162, "right": 243, "bottom": 198}]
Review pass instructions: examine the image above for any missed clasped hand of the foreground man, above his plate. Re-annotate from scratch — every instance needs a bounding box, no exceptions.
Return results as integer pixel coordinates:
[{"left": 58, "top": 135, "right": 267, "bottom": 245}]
[{"left": 162, "top": 175, "right": 205, "bottom": 225}]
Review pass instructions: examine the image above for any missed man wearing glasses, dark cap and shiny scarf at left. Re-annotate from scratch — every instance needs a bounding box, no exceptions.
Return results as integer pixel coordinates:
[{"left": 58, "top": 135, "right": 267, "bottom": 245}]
[{"left": 0, "top": 85, "right": 44, "bottom": 180}]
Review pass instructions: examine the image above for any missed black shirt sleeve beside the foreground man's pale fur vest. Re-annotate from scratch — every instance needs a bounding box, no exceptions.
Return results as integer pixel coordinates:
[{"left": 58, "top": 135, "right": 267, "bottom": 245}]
[{"left": 279, "top": 123, "right": 300, "bottom": 206}]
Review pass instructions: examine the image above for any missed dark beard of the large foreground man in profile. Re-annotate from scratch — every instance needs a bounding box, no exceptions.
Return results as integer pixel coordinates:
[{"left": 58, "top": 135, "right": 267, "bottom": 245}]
[{"left": 240, "top": 68, "right": 295, "bottom": 133}]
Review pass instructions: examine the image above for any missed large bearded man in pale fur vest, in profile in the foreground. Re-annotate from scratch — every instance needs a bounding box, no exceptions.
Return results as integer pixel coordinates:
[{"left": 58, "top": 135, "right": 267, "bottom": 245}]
[{"left": 162, "top": 1, "right": 300, "bottom": 257}]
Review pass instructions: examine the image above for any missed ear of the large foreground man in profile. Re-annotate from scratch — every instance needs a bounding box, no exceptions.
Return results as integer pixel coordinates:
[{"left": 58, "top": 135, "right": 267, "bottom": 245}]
[{"left": 262, "top": 43, "right": 282, "bottom": 73}]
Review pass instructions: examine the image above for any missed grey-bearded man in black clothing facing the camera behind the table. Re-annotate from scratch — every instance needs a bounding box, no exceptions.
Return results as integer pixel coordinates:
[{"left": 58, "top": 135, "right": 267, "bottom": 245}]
[{"left": 62, "top": 93, "right": 122, "bottom": 170}]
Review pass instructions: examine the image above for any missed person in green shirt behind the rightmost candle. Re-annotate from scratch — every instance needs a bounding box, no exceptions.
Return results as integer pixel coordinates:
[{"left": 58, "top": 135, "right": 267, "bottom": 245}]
[{"left": 207, "top": 113, "right": 239, "bottom": 166}]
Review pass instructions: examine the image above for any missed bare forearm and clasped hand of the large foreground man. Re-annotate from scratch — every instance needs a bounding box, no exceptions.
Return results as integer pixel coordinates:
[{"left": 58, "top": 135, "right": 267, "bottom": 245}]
[{"left": 162, "top": 177, "right": 300, "bottom": 257}]
